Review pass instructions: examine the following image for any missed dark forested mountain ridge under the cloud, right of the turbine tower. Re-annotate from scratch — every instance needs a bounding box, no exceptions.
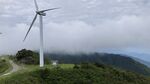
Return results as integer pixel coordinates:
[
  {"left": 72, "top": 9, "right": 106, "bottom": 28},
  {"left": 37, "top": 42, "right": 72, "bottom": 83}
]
[{"left": 46, "top": 53, "right": 150, "bottom": 75}]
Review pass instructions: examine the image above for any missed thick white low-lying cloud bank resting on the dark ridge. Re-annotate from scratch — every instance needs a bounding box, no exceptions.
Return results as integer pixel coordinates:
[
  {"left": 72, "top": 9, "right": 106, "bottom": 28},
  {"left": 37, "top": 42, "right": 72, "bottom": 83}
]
[{"left": 1, "top": 16, "right": 150, "bottom": 53}]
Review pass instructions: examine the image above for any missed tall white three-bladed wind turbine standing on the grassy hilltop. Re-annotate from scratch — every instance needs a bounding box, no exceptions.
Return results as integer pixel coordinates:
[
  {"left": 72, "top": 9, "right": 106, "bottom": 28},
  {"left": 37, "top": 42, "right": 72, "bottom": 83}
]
[{"left": 23, "top": 0, "right": 59, "bottom": 67}]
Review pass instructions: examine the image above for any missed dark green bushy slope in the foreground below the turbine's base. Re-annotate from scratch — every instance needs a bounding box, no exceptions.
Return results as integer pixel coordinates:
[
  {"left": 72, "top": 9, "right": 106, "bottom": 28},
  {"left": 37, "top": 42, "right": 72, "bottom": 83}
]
[{"left": 0, "top": 64, "right": 150, "bottom": 84}]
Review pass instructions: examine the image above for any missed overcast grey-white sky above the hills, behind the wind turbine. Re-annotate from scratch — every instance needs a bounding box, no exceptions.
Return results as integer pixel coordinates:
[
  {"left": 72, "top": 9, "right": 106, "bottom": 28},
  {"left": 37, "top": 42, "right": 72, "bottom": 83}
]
[{"left": 0, "top": 0, "right": 150, "bottom": 59}]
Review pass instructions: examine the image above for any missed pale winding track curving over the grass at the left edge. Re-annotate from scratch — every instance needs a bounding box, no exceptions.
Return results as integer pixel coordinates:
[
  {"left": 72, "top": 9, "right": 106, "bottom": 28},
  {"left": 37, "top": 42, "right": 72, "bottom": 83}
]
[{"left": 1, "top": 60, "right": 21, "bottom": 76}]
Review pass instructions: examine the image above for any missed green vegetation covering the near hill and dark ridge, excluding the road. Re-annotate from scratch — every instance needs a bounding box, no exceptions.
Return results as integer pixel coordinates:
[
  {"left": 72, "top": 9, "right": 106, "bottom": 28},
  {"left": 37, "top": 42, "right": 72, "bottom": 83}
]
[{"left": 0, "top": 49, "right": 150, "bottom": 84}]
